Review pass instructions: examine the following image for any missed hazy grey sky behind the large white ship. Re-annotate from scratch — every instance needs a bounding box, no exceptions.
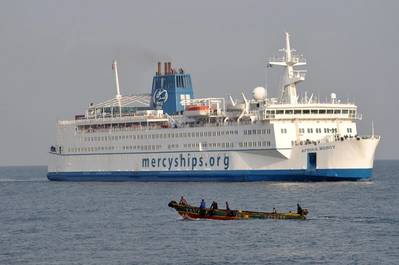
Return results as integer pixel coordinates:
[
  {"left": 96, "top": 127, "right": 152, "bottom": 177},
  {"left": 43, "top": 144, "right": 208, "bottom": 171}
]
[{"left": 0, "top": 0, "right": 399, "bottom": 165}]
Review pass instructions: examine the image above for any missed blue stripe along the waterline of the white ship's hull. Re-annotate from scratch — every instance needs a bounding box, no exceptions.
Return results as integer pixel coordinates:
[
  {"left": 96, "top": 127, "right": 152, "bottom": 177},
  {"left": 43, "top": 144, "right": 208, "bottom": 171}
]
[{"left": 47, "top": 168, "right": 372, "bottom": 181}]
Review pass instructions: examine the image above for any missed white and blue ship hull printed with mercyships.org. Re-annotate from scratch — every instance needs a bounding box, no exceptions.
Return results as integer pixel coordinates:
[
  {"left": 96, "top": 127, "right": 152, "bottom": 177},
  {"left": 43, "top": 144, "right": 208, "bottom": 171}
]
[{"left": 47, "top": 137, "right": 379, "bottom": 182}]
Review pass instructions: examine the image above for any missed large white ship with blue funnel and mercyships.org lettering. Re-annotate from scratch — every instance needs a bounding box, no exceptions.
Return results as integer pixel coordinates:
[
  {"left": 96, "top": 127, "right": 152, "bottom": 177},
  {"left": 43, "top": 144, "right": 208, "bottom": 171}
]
[{"left": 47, "top": 33, "right": 380, "bottom": 181}]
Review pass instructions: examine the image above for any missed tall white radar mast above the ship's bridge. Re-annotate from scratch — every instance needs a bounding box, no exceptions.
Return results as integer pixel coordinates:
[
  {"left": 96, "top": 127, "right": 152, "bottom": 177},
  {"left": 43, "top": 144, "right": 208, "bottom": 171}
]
[{"left": 269, "top": 32, "right": 306, "bottom": 104}]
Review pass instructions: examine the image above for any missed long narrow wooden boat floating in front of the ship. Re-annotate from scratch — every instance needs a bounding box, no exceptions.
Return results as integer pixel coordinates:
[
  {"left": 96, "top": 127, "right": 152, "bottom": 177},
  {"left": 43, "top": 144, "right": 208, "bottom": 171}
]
[{"left": 168, "top": 201, "right": 309, "bottom": 220}]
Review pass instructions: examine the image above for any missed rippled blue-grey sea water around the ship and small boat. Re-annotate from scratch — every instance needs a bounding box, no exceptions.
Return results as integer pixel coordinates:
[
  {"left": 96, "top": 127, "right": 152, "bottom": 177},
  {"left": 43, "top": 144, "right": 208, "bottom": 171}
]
[{"left": 0, "top": 161, "right": 399, "bottom": 264}]
